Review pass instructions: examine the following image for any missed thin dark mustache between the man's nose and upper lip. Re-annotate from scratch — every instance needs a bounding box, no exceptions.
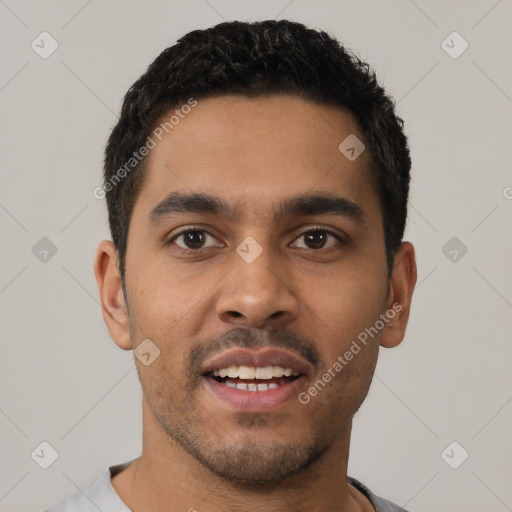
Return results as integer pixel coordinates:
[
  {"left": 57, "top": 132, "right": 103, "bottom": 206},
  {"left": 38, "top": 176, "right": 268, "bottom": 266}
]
[{"left": 188, "top": 327, "right": 320, "bottom": 375}]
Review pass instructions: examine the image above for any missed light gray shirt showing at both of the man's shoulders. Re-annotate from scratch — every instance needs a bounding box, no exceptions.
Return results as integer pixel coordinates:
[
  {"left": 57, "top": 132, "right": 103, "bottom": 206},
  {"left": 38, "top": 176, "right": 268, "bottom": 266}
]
[{"left": 44, "top": 459, "right": 407, "bottom": 512}]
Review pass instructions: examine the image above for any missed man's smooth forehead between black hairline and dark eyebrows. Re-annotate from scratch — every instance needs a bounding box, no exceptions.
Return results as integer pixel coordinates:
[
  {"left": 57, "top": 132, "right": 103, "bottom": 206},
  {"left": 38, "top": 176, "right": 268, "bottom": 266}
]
[{"left": 134, "top": 95, "right": 375, "bottom": 222}]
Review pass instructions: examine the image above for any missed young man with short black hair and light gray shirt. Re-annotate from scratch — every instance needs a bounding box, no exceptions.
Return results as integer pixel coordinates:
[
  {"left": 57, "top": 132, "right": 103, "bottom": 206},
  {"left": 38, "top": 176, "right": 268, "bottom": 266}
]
[{"left": 46, "top": 20, "right": 416, "bottom": 512}]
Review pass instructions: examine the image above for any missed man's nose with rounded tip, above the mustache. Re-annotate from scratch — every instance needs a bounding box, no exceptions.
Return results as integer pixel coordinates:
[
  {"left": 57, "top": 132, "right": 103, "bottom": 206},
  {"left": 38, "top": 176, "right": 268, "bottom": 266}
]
[{"left": 216, "top": 250, "right": 299, "bottom": 328}]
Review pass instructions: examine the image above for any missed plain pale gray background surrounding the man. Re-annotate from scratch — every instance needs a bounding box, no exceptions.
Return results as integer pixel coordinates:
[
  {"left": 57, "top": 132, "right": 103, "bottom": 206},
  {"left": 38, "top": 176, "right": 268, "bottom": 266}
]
[{"left": 0, "top": 0, "right": 512, "bottom": 512}]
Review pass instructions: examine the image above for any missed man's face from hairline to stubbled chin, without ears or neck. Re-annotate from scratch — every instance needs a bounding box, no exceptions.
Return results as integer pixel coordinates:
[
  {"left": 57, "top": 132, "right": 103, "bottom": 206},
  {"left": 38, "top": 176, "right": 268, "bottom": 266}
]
[{"left": 97, "top": 95, "right": 416, "bottom": 482}]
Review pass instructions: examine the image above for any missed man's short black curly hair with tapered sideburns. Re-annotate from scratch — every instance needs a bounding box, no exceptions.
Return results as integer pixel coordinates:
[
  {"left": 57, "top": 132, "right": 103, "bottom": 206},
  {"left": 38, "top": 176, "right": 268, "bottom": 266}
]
[{"left": 103, "top": 20, "right": 411, "bottom": 289}]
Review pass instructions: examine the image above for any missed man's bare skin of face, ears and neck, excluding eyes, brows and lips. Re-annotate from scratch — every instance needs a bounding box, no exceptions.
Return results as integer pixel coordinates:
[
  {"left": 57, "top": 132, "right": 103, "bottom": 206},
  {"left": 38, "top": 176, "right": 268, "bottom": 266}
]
[{"left": 95, "top": 95, "right": 416, "bottom": 512}]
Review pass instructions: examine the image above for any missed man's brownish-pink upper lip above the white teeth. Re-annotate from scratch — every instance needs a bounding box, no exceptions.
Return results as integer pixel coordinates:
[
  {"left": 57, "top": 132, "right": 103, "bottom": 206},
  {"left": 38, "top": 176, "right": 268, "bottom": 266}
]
[{"left": 202, "top": 348, "right": 308, "bottom": 375}]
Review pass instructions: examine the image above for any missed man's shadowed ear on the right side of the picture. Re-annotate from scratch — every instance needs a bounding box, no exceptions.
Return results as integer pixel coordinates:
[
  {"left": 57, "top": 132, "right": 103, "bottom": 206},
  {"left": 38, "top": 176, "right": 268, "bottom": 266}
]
[{"left": 380, "top": 242, "right": 417, "bottom": 348}]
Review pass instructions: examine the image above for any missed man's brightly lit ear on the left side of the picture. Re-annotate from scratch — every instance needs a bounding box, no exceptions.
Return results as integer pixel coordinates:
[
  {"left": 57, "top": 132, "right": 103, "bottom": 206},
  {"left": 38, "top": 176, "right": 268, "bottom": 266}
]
[{"left": 94, "top": 240, "right": 132, "bottom": 350}]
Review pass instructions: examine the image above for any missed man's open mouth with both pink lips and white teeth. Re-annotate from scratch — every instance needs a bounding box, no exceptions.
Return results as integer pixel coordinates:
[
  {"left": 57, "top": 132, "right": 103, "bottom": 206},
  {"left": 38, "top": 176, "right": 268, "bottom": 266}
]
[{"left": 203, "top": 349, "right": 310, "bottom": 412}]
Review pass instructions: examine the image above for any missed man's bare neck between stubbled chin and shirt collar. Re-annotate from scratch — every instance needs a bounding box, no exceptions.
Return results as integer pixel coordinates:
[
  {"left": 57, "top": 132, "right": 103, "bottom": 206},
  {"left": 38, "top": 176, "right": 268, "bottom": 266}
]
[{"left": 112, "top": 399, "right": 373, "bottom": 512}]
